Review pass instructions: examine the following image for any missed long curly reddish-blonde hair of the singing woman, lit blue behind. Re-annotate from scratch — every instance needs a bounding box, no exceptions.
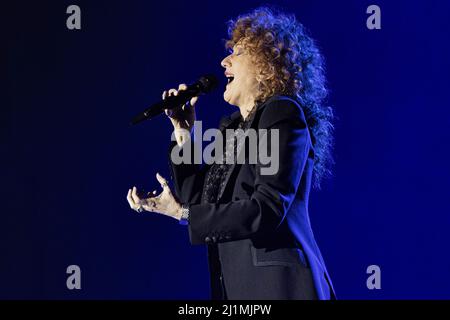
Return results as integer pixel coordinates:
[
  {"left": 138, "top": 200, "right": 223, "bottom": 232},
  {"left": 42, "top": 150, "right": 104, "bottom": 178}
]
[{"left": 225, "top": 7, "right": 333, "bottom": 188}]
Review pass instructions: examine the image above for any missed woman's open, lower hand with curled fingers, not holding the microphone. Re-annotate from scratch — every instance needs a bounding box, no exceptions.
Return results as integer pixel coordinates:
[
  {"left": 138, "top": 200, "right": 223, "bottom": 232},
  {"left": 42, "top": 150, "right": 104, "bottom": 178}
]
[{"left": 127, "top": 173, "right": 181, "bottom": 220}]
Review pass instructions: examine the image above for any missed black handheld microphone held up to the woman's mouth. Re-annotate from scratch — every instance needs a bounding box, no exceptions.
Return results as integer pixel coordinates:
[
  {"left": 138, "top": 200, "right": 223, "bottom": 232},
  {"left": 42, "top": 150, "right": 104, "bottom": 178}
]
[{"left": 131, "top": 74, "right": 218, "bottom": 125}]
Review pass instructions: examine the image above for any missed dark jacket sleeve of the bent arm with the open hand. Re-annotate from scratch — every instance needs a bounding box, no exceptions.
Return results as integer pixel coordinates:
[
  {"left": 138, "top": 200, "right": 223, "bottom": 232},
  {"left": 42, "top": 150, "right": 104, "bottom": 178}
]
[{"left": 189, "top": 98, "right": 310, "bottom": 244}]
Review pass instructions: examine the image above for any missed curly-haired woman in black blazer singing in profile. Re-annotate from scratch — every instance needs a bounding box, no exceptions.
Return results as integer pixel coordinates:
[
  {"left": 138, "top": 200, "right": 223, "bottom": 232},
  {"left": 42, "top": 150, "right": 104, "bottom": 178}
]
[{"left": 127, "top": 7, "right": 335, "bottom": 300}]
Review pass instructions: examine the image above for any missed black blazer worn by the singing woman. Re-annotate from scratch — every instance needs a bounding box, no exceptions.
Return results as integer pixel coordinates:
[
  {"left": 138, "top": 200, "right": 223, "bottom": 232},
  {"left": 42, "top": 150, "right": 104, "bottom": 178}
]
[{"left": 169, "top": 96, "right": 334, "bottom": 299}]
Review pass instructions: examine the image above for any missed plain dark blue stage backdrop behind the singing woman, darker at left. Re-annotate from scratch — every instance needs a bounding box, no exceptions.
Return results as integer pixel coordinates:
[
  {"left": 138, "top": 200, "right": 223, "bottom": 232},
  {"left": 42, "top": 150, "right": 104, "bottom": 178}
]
[{"left": 0, "top": 0, "right": 450, "bottom": 299}]
